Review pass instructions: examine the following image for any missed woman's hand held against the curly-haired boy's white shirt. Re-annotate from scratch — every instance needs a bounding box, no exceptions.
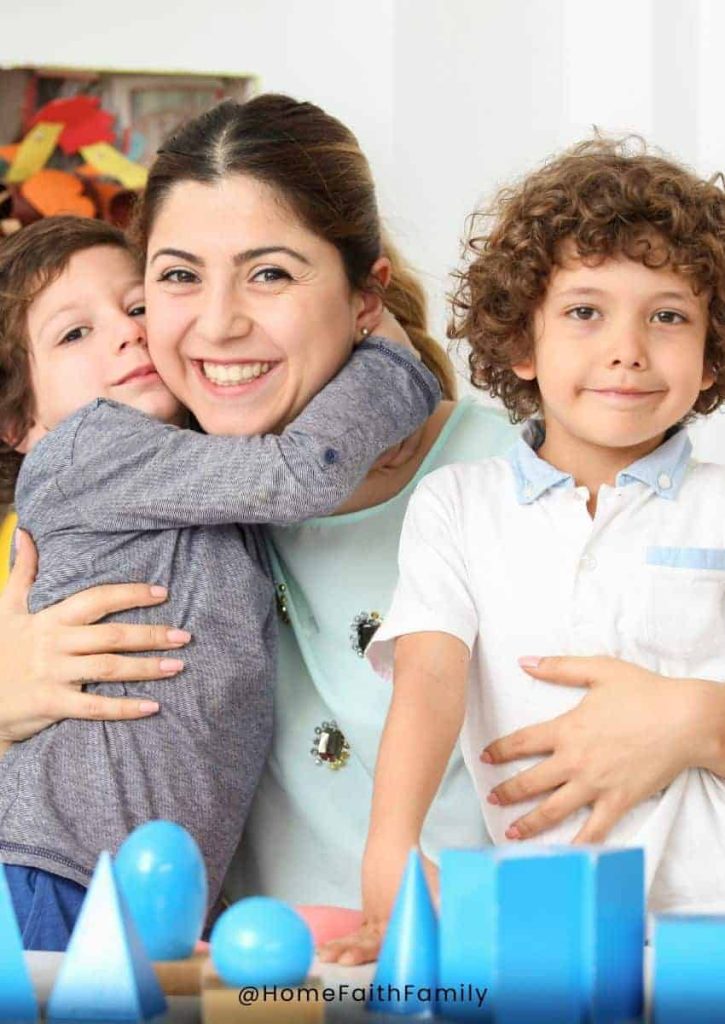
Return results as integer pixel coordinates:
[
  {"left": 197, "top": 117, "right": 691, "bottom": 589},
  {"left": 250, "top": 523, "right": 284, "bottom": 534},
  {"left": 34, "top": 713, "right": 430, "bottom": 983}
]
[{"left": 481, "top": 657, "right": 725, "bottom": 843}]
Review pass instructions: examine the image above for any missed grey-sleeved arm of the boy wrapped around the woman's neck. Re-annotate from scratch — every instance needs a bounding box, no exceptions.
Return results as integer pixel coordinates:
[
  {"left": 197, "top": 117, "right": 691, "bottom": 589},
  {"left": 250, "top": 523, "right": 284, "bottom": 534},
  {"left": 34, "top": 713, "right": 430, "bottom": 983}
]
[{"left": 57, "top": 339, "right": 440, "bottom": 531}]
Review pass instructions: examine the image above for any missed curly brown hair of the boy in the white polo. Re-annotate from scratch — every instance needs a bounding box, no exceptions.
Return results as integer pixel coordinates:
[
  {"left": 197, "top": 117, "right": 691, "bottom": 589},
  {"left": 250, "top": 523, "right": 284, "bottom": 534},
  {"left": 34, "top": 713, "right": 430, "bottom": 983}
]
[{"left": 449, "top": 136, "right": 725, "bottom": 423}]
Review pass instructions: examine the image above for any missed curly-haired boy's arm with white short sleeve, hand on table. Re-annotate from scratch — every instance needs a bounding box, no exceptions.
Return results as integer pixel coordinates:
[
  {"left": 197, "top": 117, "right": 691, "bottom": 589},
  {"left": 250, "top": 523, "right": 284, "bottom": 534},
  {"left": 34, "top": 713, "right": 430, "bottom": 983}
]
[{"left": 319, "top": 470, "right": 478, "bottom": 964}]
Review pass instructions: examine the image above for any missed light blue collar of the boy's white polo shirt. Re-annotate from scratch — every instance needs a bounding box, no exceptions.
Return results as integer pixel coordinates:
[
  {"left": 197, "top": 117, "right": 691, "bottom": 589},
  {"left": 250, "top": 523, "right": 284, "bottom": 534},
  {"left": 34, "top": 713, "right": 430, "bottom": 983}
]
[{"left": 506, "top": 420, "right": 692, "bottom": 505}]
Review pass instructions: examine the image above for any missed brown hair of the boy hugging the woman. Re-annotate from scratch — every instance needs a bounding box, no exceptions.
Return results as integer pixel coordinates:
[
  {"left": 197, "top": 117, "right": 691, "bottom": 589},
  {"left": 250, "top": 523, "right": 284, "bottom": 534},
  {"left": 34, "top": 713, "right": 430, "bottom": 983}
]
[{"left": 0, "top": 217, "right": 136, "bottom": 506}]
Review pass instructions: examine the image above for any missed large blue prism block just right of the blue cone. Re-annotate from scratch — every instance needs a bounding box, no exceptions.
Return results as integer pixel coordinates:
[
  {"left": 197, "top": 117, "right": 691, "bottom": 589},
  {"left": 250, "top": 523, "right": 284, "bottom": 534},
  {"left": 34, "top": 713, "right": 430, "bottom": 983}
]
[{"left": 438, "top": 844, "right": 644, "bottom": 1024}]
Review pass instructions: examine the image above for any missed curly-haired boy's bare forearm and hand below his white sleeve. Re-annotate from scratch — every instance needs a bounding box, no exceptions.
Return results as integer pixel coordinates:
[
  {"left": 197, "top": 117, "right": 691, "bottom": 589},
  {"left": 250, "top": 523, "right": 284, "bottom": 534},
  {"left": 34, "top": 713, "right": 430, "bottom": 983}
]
[{"left": 318, "top": 633, "right": 469, "bottom": 965}]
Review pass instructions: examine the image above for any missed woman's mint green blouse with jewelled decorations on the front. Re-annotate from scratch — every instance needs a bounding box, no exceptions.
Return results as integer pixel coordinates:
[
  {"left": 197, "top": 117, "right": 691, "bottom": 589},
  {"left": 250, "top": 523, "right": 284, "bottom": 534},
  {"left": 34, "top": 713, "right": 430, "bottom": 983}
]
[{"left": 226, "top": 399, "right": 517, "bottom": 907}]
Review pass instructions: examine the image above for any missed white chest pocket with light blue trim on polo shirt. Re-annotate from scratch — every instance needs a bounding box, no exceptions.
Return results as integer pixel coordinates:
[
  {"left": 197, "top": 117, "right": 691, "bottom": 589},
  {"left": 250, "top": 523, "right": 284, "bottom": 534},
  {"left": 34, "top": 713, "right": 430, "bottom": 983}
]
[{"left": 640, "top": 547, "right": 725, "bottom": 658}]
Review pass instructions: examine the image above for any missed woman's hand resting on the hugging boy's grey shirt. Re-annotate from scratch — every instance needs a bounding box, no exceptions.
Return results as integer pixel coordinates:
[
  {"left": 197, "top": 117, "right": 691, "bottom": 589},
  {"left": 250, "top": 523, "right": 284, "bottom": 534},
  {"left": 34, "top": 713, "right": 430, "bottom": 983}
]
[{"left": 0, "top": 530, "right": 190, "bottom": 740}]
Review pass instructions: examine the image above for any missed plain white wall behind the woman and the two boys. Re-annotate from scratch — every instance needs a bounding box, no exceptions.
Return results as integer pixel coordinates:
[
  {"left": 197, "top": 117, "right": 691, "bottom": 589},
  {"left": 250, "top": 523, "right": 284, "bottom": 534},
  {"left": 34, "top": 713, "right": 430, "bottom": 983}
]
[{"left": 0, "top": 0, "right": 725, "bottom": 461}]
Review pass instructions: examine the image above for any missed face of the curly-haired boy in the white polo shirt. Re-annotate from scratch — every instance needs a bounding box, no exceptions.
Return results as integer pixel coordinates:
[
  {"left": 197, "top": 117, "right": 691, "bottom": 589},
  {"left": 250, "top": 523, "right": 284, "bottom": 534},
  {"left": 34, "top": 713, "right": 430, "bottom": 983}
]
[{"left": 513, "top": 243, "right": 714, "bottom": 449}]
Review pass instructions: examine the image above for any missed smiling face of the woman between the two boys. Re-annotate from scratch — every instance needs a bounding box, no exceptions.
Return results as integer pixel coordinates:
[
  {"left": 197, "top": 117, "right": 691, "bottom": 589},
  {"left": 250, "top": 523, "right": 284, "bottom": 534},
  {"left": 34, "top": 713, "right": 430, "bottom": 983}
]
[{"left": 145, "top": 174, "right": 374, "bottom": 434}]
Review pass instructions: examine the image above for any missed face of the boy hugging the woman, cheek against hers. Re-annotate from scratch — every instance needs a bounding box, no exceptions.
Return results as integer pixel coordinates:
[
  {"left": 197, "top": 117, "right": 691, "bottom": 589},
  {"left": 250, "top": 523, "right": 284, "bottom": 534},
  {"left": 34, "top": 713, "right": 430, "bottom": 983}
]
[{"left": 18, "top": 246, "right": 180, "bottom": 452}]
